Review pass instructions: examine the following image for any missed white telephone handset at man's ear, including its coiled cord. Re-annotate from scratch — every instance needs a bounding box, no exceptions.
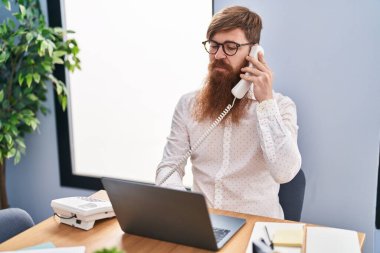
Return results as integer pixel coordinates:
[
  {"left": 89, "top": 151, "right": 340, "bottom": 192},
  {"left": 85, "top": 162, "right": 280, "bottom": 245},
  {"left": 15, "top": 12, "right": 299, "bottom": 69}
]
[{"left": 156, "top": 44, "right": 264, "bottom": 186}]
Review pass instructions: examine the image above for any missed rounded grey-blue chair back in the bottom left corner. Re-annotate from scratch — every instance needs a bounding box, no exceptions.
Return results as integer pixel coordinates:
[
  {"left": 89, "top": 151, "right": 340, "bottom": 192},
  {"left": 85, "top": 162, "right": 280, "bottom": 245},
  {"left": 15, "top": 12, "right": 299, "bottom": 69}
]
[{"left": 0, "top": 208, "right": 34, "bottom": 243}]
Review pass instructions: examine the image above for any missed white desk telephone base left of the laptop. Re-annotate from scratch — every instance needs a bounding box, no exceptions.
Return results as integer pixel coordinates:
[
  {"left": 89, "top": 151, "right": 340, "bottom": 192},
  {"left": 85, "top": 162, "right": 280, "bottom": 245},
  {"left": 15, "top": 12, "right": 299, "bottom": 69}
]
[{"left": 50, "top": 197, "right": 115, "bottom": 230}]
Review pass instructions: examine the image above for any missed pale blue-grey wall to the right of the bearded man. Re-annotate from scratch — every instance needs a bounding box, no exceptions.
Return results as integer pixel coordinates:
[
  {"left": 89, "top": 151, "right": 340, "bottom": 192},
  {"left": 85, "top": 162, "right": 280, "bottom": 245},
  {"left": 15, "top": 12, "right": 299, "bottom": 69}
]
[{"left": 215, "top": 0, "right": 380, "bottom": 253}]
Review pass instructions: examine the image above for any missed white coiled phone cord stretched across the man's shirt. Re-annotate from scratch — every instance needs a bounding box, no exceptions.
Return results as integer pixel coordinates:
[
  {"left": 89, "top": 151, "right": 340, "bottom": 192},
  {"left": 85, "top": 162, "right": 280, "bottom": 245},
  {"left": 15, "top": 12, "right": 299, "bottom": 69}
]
[{"left": 157, "top": 97, "right": 236, "bottom": 186}]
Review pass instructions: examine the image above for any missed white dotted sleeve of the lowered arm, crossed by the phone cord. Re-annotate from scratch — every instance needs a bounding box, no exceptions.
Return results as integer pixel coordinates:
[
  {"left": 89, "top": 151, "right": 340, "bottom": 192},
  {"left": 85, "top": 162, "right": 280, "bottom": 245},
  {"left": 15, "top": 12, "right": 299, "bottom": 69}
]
[{"left": 156, "top": 96, "right": 190, "bottom": 190}]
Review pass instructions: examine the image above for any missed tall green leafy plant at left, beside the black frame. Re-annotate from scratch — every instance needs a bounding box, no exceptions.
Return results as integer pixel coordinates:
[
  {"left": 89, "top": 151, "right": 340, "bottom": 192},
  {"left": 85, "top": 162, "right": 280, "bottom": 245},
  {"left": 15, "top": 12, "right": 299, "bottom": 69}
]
[{"left": 0, "top": 0, "right": 80, "bottom": 209}]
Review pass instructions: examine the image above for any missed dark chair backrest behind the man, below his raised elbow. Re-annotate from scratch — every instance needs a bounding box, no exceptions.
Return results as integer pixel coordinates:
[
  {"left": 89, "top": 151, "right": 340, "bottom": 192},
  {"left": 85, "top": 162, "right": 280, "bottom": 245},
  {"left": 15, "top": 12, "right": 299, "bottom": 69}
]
[{"left": 278, "top": 170, "right": 306, "bottom": 221}]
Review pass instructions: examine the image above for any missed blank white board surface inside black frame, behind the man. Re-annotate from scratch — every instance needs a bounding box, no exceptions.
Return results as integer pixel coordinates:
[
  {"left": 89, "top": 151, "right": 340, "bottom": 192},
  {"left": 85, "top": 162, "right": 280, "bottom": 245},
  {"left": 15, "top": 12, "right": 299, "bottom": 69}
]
[{"left": 61, "top": 0, "right": 212, "bottom": 186}]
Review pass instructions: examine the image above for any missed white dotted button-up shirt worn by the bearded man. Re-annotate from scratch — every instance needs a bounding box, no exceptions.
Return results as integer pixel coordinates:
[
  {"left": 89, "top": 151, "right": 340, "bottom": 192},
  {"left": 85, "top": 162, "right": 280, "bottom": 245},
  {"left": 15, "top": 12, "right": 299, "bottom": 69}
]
[{"left": 156, "top": 92, "right": 301, "bottom": 219}]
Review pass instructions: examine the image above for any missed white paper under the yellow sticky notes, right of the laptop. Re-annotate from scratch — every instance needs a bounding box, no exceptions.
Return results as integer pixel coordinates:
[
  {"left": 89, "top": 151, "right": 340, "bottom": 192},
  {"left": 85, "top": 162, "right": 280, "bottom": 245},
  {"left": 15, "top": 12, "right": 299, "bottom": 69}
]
[{"left": 246, "top": 222, "right": 304, "bottom": 253}]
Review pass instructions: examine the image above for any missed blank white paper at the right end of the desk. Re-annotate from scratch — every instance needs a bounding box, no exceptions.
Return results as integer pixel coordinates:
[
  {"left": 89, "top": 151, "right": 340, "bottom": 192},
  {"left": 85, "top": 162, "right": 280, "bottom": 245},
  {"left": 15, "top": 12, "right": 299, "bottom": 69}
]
[{"left": 306, "top": 227, "right": 361, "bottom": 253}]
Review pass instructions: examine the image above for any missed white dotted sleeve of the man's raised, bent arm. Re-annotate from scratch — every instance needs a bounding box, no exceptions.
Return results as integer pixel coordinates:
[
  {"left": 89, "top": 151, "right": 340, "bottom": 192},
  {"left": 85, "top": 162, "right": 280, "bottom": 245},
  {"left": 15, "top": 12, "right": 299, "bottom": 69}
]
[{"left": 256, "top": 97, "right": 301, "bottom": 184}]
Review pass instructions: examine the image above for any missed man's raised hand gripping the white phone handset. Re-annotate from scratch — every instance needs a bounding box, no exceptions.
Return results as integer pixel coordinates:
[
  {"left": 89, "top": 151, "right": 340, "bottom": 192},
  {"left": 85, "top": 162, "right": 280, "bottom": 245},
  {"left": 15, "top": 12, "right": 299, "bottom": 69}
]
[{"left": 240, "top": 52, "right": 273, "bottom": 103}]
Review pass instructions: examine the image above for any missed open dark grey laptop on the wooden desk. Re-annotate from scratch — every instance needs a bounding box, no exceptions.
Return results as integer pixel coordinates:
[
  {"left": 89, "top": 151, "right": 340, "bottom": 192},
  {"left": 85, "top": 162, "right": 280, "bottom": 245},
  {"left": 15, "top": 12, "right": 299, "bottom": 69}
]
[{"left": 101, "top": 178, "right": 245, "bottom": 250}]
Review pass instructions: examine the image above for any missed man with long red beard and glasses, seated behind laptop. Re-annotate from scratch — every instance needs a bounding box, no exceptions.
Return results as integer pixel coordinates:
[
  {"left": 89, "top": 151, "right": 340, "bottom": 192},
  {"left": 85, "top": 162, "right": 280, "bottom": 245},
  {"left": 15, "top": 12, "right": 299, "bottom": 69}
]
[{"left": 156, "top": 6, "right": 301, "bottom": 218}]
